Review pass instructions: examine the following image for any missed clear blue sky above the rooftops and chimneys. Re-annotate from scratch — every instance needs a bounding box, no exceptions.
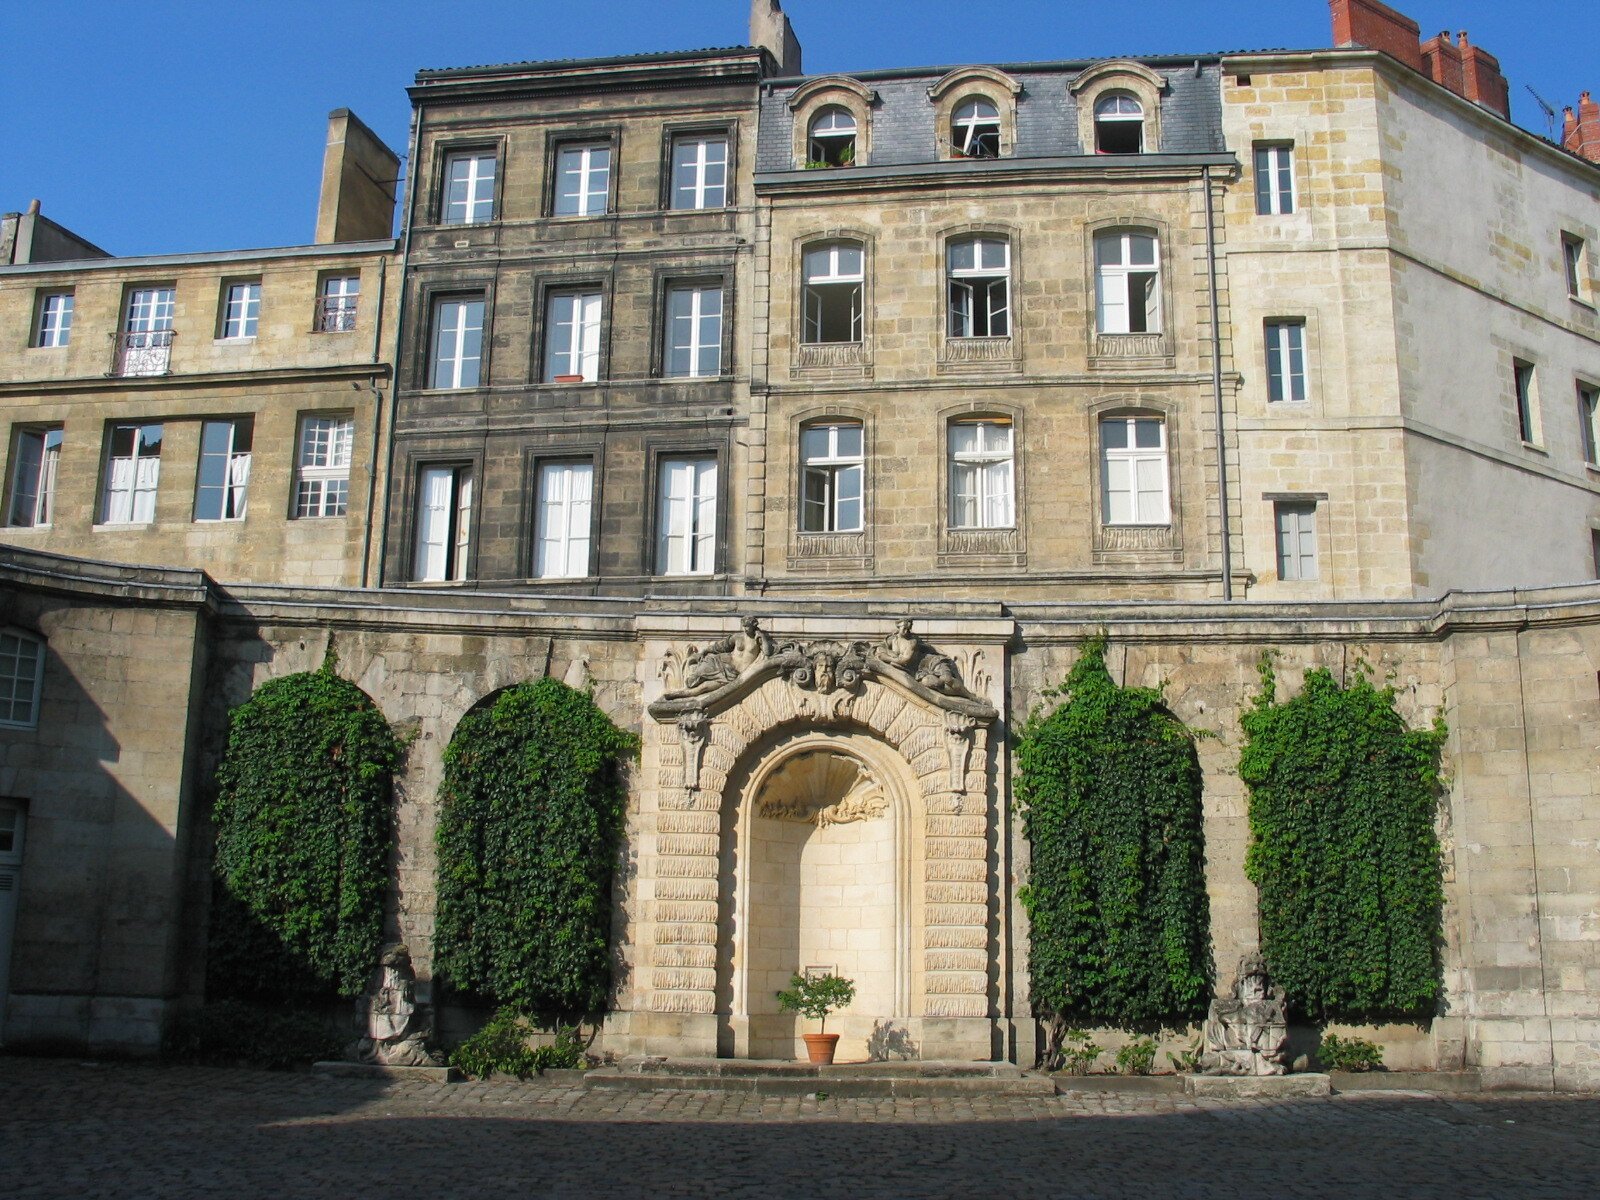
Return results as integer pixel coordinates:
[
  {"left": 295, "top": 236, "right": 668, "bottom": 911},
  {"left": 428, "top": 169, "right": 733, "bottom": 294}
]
[{"left": 0, "top": 0, "right": 1600, "bottom": 254}]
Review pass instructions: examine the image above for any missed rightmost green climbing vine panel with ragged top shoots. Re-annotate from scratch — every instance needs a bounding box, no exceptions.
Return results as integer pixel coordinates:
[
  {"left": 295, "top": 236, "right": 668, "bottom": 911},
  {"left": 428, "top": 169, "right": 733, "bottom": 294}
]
[{"left": 1238, "top": 656, "right": 1445, "bottom": 1019}]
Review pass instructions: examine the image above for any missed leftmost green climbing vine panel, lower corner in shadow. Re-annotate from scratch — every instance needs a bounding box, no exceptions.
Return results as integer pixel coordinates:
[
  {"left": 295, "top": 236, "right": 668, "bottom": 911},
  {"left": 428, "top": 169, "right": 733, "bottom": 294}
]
[{"left": 206, "top": 653, "right": 403, "bottom": 1002}]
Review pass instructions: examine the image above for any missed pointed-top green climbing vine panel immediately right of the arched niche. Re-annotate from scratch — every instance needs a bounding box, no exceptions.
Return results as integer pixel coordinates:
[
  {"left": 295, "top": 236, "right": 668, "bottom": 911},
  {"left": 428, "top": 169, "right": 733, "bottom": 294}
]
[{"left": 1016, "top": 637, "right": 1211, "bottom": 1045}]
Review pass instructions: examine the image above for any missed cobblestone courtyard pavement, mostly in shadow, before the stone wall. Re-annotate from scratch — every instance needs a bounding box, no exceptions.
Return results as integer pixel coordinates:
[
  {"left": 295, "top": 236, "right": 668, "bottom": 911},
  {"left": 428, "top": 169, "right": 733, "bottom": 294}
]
[{"left": 0, "top": 1058, "right": 1600, "bottom": 1200}]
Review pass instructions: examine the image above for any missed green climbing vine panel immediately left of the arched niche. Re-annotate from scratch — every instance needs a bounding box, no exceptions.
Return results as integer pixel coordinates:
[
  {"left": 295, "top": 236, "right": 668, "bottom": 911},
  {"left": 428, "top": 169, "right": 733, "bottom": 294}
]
[{"left": 434, "top": 678, "right": 637, "bottom": 1018}]
